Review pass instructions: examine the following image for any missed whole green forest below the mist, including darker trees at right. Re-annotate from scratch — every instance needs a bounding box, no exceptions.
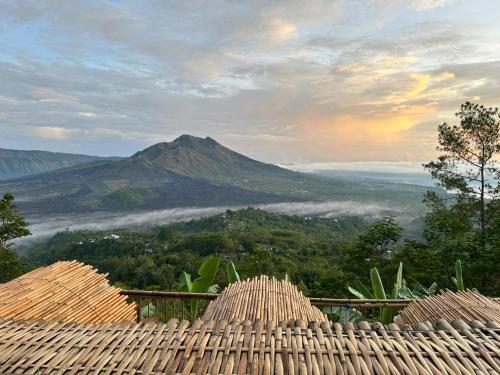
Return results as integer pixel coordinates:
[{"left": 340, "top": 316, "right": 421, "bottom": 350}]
[{"left": 18, "top": 201, "right": 500, "bottom": 298}]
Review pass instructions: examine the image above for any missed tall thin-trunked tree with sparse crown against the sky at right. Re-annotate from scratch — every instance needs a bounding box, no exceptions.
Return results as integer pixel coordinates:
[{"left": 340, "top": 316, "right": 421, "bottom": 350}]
[{"left": 424, "top": 102, "right": 500, "bottom": 252}]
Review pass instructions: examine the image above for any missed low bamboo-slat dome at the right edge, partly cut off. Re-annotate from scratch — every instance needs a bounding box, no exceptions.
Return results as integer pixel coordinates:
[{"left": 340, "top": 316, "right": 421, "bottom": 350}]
[{"left": 394, "top": 290, "right": 500, "bottom": 325}]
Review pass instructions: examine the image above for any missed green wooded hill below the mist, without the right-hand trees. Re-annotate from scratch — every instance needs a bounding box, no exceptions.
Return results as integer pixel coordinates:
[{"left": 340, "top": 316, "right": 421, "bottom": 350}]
[{"left": 28, "top": 209, "right": 368, "bottom": 296}]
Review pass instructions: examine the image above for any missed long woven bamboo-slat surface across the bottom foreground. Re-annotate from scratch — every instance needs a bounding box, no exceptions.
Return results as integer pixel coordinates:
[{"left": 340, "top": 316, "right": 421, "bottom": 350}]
[{"left": 0, "top": 319, "right": 500, "bottom": 375}]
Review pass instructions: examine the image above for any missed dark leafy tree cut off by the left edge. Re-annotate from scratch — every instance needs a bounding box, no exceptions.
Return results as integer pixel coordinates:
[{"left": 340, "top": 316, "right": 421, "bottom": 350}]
[{"left": 0, "top": 193, "right": 31, "bottom": 282}]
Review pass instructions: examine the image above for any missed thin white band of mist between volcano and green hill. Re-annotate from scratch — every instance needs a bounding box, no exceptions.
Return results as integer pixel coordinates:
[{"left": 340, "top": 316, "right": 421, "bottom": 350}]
[{"left": 17, "top": 201, "right": 401, "bottom": 244}]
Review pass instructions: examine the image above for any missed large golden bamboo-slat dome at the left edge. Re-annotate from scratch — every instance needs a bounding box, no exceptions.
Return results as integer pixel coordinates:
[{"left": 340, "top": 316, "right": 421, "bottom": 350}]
[{"left": 0, "top": 261, "right": 137, "bottom": 323}]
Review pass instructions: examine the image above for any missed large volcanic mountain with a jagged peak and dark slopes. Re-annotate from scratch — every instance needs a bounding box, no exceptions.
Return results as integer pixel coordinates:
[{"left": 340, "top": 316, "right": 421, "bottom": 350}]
[{"left": 0, "top": 135, "right": 434, "bottom": 214}]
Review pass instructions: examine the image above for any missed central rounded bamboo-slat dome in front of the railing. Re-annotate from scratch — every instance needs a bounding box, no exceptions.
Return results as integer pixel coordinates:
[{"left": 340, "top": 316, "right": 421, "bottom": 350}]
[{"left": 202, "top": 275, "right": 327, "bottom": 322}]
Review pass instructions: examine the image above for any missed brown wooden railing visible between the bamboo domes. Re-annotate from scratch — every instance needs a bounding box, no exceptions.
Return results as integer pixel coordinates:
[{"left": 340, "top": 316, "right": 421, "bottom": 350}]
[{"left": 121, "top": 290, "right": 410, "bottom": 322}]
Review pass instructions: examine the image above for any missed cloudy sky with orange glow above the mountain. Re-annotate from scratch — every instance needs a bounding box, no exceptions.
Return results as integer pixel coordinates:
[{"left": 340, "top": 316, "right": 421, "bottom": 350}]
[{"left": 0, "top": 0, "right": 500, "bottom": 166}]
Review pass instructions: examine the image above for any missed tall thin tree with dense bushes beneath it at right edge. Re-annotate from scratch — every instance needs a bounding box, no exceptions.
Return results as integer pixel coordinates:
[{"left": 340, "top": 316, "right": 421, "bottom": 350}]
[{"left": 424, "top": 102, "right": 500, "bottom": 291}]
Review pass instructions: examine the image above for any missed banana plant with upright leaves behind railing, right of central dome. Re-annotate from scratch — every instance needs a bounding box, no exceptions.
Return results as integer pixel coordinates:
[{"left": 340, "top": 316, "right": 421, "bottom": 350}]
[{"left": 348, "top": 262, "right": 404, "bottom": 324}]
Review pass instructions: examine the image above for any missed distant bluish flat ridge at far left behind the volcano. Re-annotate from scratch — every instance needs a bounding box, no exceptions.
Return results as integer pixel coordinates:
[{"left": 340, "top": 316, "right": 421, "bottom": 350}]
[{"left": 0, "top": 148, "right": 122, "bottom": 180}]
